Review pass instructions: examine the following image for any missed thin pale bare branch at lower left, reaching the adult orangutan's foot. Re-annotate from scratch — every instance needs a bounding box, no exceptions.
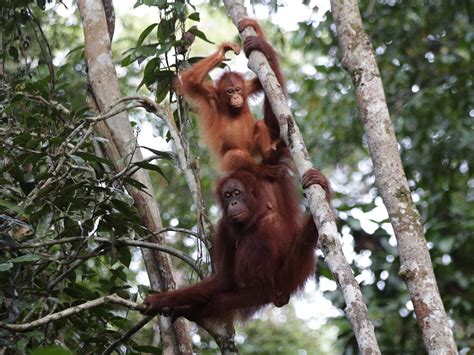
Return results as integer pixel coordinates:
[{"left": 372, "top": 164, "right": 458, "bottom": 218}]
[{"left": 0, "top": 294, "right": 146, "bottom": 332}]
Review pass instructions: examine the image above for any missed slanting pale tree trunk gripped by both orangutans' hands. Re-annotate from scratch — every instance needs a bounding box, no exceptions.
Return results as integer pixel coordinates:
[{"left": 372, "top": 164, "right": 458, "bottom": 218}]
[{"left": 224, "top": 0, "right": 380, "bottom": 354}]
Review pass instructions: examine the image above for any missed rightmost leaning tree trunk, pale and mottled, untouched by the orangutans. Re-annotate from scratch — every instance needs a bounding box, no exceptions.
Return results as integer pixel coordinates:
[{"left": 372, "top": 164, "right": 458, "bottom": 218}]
[{"left": 331, "top": 0, "right": 457, "bottom": 354}]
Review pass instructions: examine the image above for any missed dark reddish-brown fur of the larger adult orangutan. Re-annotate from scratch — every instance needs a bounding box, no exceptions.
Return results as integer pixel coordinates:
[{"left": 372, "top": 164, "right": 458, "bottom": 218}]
[{"left": 144, "top": 160, "right": 329, "bottom": 322}]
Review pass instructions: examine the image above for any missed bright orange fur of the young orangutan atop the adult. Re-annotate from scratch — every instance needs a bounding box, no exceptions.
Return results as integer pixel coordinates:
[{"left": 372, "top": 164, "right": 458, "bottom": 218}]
[{"left": 177, "top": 19, "right": 283, "bottom": 172}]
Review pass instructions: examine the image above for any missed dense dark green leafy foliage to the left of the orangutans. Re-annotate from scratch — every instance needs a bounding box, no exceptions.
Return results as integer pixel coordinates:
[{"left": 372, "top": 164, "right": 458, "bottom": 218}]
[{"left": 0, "top": 2, "right": 169, "bottom": 354}]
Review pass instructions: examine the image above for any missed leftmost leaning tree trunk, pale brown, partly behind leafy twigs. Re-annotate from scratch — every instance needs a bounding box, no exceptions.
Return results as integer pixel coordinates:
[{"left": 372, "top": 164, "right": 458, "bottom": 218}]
[{"left": 79, "top": 0, "right": 192, "bottom": 354}]
